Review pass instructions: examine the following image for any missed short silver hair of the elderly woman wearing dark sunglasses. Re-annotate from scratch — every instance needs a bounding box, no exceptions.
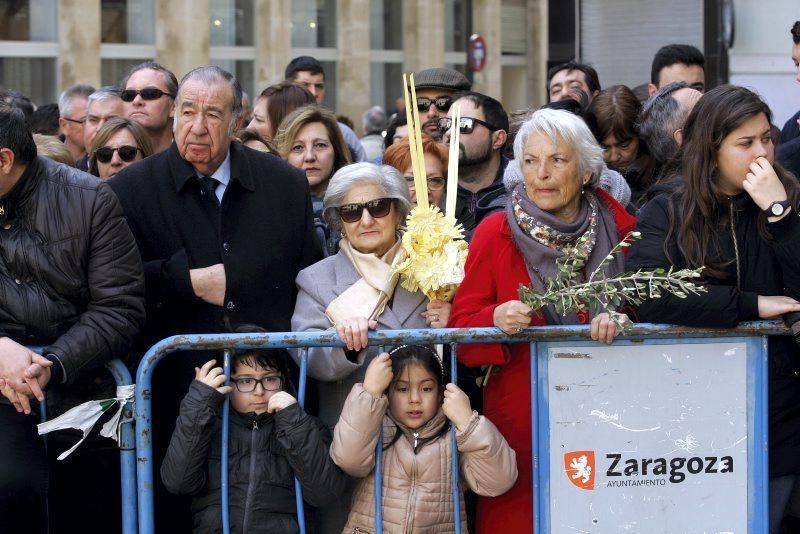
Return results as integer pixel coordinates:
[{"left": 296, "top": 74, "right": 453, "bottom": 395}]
[{"left": 322, "top": 162, "right": 411, "bottom": 234}]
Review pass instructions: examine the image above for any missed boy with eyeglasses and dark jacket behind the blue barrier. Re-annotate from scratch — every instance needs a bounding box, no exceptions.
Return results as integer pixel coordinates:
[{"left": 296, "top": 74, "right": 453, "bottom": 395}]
[{"left": 161, "top": 349, "right": 346, "bottom": 534}]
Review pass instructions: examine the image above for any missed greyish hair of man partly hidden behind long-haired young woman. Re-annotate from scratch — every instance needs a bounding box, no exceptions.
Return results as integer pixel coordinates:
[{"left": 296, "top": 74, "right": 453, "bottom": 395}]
[{"left": 637, "top": 82, "right": 689, "bottom": 165}]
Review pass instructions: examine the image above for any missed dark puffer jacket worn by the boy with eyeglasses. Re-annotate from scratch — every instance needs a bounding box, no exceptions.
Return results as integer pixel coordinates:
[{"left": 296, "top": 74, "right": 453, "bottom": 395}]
[{"left": 161, "top": 380, "right": 347, "bottom": 534}]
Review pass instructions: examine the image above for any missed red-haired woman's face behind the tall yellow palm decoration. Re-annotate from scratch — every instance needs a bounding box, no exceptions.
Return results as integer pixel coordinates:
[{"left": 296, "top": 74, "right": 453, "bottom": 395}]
[{"left": 383, "top": 134, "right": 449, "bottom": 209}]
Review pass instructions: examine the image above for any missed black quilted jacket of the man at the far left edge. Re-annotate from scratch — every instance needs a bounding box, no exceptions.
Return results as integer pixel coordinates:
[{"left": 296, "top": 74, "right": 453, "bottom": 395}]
[{"left": 0, "top": 158, "right": 145, "bottom": 408}]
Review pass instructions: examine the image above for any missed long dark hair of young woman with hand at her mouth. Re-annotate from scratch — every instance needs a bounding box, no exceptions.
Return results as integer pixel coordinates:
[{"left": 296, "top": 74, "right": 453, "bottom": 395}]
[{"left": 665, "top": 85, "right": 800, "bottom": 278}]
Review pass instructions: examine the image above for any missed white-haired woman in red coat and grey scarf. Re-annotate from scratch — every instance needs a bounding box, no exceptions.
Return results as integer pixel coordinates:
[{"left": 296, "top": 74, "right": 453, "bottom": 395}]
[{"left": 448, "top": 109, "right": 636, "bottom": 533}]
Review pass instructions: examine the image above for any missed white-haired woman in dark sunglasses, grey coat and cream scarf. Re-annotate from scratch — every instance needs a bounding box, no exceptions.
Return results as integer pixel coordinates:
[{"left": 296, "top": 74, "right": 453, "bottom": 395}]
[{"left": 292, "top": 163, "right": 450, "bottom": 532}]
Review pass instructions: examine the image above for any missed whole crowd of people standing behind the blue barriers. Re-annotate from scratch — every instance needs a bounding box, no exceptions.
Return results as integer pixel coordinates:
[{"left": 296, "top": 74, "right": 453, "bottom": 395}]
[{"left": 0, "top": 21, "right": 800, "bottom": 534}]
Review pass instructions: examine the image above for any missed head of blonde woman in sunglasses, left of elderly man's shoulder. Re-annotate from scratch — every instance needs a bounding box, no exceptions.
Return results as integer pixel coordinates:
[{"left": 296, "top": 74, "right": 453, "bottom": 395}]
[{"left": 89, "top": 117, "right": 153, "bottom": 180}]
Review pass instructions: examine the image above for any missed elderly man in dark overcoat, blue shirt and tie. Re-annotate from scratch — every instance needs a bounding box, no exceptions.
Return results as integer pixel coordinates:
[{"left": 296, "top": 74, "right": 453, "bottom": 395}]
[{"left": 109, "top": 67, "right": 322, "bottom": 532}]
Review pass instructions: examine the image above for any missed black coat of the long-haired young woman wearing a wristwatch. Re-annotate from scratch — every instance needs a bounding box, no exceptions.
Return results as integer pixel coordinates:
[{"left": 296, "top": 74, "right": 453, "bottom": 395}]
[{"left": 625, "top": 193, "right": 800, "bottom": 477}]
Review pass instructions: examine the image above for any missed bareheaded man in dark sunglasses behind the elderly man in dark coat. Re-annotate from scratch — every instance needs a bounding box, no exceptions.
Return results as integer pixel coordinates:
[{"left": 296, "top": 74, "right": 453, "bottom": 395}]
[{"left": 120, "top": 61, "right": 178, "bottom": 154}]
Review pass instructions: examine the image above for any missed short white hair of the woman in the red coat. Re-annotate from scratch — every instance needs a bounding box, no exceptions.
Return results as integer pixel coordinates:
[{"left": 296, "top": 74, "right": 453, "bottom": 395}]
[{"left": 514, "top": 108, "right": 605, "bottom": 188}]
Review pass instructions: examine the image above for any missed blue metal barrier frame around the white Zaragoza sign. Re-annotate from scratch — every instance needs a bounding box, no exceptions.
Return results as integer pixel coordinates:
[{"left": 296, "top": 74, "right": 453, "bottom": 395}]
[{"left": 135, "top": 322, "right": 788, "bottom": 534}]
